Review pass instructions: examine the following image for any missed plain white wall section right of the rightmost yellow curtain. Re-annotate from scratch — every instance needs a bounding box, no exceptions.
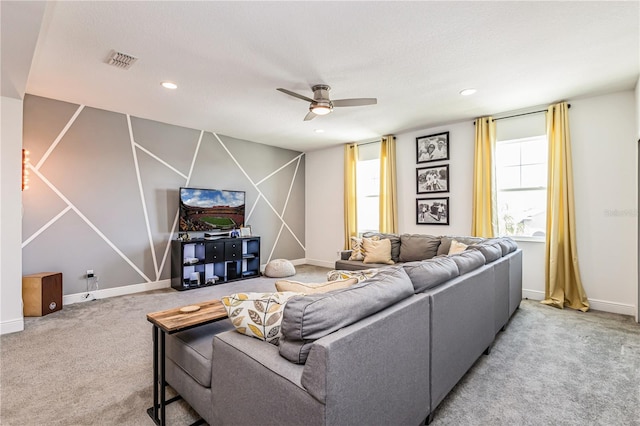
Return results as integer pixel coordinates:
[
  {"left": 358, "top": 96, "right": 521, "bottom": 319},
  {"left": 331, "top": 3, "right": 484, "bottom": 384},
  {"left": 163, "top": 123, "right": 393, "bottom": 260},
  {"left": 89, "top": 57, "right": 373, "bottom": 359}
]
[{"left": 569, "top": 91, "right": 638, "bottom": 315}]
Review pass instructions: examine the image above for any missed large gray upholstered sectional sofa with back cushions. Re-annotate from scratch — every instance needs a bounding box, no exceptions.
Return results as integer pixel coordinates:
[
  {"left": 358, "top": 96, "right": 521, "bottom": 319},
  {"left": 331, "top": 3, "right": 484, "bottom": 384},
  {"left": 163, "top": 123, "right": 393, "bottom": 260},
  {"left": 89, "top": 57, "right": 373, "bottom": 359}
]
[{"left": 166, "top": 235, "right": 522, "bottom": 425}]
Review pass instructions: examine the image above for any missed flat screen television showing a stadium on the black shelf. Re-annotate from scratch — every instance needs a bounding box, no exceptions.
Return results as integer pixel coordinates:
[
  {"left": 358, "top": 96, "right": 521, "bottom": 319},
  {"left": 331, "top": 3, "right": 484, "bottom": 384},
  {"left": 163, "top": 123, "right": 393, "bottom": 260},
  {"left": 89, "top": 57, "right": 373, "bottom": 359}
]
[{"left": 178, "top": 188, "right": 245, "bottom": 233}]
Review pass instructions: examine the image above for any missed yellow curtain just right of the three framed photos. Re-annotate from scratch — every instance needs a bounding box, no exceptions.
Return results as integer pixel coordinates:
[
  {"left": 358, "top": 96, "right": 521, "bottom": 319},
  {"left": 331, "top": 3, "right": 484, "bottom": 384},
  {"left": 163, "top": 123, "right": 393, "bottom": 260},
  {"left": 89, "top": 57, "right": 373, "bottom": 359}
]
[{"left": 471, "top": 117, "right": 498, "bottom": 238}]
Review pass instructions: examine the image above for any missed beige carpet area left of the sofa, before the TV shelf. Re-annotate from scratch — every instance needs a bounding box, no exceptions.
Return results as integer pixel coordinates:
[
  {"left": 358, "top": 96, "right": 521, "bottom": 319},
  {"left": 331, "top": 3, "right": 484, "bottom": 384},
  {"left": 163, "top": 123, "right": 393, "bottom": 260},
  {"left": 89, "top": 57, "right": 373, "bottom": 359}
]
[{"left": 0, "top": 265, "right": 329, "bottom": 426}]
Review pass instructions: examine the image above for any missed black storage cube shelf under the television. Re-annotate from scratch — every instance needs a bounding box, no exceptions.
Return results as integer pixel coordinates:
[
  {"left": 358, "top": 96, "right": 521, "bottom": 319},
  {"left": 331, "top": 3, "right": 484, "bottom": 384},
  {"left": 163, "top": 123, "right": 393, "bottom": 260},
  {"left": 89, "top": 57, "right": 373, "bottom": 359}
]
[{"left": 171, "top": 237, "right": 260, "bottom": 290}]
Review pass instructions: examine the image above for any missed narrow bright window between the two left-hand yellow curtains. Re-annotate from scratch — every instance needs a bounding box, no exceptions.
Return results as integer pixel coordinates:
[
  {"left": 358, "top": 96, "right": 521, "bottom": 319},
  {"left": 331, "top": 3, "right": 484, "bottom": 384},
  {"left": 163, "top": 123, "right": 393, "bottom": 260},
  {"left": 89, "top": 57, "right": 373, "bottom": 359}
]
[{"left": 356, "top": 142, "right": 380, "bottom": 235}]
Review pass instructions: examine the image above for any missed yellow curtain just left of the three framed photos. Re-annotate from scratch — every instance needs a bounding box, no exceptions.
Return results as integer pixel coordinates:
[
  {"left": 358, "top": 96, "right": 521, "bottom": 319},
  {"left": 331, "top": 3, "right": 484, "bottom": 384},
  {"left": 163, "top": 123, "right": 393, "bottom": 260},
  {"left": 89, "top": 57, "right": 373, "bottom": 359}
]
[{"left": 380, "top": 135, "right": 398, "bottom": 234}]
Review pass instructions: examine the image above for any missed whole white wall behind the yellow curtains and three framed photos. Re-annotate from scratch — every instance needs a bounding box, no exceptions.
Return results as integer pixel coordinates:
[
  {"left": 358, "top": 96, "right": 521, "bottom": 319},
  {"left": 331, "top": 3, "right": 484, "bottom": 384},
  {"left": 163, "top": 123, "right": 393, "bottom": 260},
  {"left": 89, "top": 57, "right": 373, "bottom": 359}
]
[{"left": 306, "top": 91, "right": 638, "bottom": 315}]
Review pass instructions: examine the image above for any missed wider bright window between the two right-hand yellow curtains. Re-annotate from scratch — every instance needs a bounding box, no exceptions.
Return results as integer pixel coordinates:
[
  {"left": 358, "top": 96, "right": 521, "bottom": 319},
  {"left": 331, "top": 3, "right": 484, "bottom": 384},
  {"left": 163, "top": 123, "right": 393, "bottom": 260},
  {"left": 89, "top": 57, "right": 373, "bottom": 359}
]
[{"left": 496, "top": 136, "right": 548, "bottom": 237}]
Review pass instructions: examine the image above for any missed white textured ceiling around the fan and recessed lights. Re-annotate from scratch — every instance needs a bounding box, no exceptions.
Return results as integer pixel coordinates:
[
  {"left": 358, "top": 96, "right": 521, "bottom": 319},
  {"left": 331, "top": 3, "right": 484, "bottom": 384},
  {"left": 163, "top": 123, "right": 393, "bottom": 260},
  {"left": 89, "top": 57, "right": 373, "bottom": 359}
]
[{"left": 2, "top": 1, "right": 640, "bottom": 151}]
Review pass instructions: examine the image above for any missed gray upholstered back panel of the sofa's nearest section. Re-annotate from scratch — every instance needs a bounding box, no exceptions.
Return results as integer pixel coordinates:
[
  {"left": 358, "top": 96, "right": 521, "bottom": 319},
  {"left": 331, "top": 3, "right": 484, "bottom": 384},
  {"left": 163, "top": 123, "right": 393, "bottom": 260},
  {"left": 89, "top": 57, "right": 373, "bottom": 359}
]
[{"left": 302, "top": 294, "right": 430, "bottom": 424}]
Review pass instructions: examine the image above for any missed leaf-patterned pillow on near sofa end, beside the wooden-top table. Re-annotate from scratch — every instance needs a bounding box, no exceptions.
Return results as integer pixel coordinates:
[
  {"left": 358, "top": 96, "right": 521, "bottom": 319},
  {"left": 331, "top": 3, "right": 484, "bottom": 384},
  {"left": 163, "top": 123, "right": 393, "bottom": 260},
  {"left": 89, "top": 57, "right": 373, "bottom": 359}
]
[{"left": 221, "top": 291, "right": 299, "bottom": 346}]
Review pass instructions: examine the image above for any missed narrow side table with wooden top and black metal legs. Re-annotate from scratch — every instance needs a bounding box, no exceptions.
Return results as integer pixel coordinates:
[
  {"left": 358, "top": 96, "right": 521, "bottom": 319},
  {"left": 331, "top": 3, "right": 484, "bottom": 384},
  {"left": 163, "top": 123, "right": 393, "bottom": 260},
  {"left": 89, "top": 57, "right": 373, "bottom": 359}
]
[{"left": 147, "top": 299, "right": 227, "bottom": 425}]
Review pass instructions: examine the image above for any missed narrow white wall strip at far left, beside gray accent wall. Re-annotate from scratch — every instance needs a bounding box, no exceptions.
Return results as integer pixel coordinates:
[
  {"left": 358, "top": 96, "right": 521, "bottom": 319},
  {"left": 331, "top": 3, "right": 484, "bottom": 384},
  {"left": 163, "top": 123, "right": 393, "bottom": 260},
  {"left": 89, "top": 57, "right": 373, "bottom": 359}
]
[{"left": 0, "top": 96, "right": 24, "bottom": 334}]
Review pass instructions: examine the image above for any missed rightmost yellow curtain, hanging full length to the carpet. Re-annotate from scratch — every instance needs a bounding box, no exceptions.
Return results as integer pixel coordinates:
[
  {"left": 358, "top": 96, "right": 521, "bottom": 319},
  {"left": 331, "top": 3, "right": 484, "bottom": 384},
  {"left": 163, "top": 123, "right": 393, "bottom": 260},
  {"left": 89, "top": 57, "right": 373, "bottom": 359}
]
[{"left": 542, "top": 102, "right": 589, "bottom": 312}]
